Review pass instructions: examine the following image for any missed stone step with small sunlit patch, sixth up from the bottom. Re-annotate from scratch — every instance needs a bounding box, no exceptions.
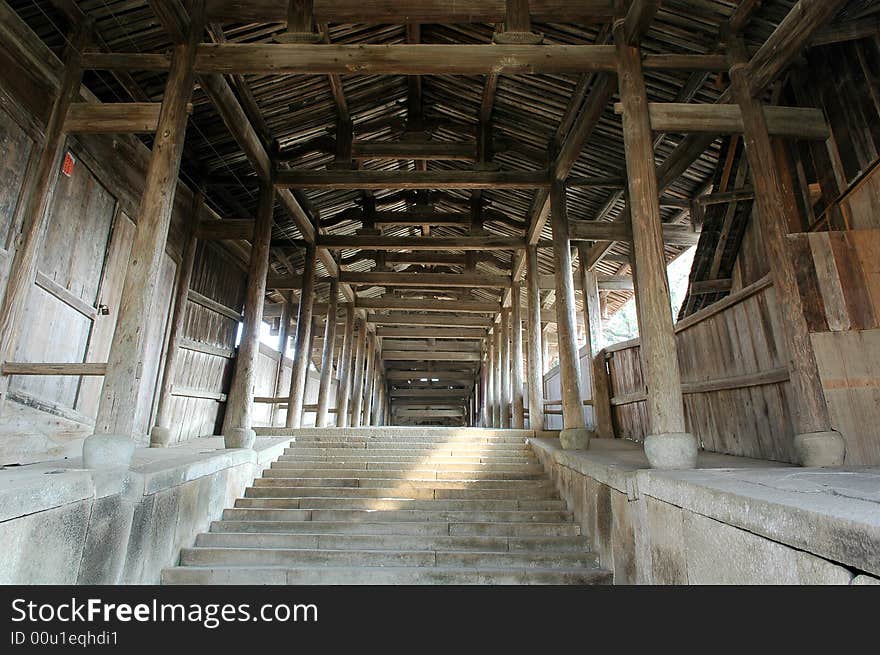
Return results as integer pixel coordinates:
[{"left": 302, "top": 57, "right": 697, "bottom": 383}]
[{"left": 235, "top": 496, "right": 566, "bottom": 512}]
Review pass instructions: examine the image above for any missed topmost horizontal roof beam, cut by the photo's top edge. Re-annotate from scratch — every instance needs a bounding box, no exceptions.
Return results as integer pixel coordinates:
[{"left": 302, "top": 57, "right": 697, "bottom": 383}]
[{"left": 206, "top": 0, "right": 619, "bottom": 25}]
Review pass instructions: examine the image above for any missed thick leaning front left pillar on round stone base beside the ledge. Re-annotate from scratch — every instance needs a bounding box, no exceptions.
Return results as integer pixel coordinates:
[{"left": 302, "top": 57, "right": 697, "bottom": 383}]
[{"left": 83, "top": 34, "right": 201, "bottom": 468}]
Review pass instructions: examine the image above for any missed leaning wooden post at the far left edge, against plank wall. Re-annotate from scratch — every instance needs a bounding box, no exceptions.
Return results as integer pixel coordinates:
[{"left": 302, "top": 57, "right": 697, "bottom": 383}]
[{"left": 0, "top": 29, "right": 86, "bottom": 412}]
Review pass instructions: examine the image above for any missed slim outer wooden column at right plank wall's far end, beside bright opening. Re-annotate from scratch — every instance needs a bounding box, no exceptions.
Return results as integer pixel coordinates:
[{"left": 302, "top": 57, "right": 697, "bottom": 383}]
[{"left": 577, "top": 242, "right": 613, "bottom": 439}]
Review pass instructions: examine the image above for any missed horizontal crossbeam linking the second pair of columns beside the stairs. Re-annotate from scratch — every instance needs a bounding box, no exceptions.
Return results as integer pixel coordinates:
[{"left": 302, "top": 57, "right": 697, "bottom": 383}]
[{"left": 275, "top": 170, "right": 549, "bottom": 190}]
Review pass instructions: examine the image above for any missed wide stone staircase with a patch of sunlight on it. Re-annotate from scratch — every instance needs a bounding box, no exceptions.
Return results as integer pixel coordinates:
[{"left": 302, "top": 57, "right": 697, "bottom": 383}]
[{"left": 162, "top": 428, "right": 611, "bottom": 585}]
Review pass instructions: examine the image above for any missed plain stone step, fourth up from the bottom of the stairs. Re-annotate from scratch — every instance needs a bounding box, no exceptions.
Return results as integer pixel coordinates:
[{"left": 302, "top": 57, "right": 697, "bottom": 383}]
[{"left": 211, "top": 518, "right": 580, "bottom": 537}]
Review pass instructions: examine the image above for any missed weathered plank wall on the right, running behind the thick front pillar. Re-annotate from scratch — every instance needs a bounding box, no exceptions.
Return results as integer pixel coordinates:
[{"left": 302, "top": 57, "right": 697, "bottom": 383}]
[{"left": 606, "top": 278, "right": 794, "bottom": 462}]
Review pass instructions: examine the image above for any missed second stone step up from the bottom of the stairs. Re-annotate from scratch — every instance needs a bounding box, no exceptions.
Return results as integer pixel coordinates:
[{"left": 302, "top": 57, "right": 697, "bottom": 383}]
[{"left": 180, "top": 547, "right": 596, "bottom": 569}]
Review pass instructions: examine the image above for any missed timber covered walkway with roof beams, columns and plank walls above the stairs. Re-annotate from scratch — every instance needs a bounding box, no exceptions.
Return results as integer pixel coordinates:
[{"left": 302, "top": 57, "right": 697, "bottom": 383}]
[{"left": 0, "top": 0, "right": 880, "bottom": 468}]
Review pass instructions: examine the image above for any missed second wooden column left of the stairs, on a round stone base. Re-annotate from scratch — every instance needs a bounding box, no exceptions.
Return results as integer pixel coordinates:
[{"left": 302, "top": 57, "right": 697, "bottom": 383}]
[{"left": 223, "top": 182, "right": 275, "bottom": 448}]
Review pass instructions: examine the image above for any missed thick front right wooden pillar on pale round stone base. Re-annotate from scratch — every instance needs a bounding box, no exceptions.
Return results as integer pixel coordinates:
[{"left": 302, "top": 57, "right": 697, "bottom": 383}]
[{"left": 614, "top": 21, "right": 698, "bottom": 469}]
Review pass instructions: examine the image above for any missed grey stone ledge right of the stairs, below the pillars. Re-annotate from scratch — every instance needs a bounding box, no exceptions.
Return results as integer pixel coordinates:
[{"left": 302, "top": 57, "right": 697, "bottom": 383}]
[{"left": 530, "top": 439, "right": 880, "bottom": 575}]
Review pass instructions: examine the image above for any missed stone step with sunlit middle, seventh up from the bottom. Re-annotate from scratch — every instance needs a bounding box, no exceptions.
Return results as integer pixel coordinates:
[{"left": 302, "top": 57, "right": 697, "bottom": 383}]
[{"left": 244, "top": 486, "right": 558, "bottom": 501}]
